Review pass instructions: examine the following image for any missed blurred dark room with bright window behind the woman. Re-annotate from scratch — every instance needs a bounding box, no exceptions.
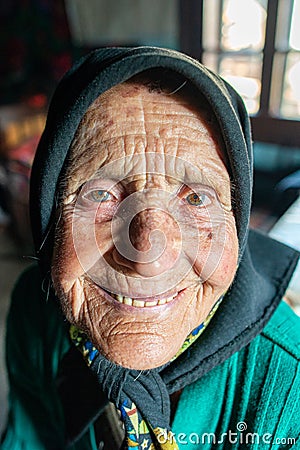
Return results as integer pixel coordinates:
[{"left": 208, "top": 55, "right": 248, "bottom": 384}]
[{"left": 0, "top": 0, "right": 300, "bottom": 431}]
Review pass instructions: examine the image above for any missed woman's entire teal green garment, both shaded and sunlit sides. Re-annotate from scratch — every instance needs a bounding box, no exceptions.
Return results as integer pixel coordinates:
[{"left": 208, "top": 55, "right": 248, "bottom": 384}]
[{"left": 1, "top": 268, "right": 300, "bottom": 450}]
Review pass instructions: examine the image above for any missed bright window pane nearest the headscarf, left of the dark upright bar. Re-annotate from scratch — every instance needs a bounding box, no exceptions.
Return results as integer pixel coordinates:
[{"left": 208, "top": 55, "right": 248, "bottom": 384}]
[{"left": 202, "top": 0, "right": 267, "bottom": 114}]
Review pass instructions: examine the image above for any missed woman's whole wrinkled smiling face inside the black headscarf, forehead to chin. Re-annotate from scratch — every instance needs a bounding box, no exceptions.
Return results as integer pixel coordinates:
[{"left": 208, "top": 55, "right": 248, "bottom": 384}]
[{"left": 52, "top": 82, "right": 238, "bottom": 369}]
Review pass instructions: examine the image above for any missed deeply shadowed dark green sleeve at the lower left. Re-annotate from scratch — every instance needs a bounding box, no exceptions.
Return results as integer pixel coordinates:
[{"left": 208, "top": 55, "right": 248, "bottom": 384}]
[{"left": 0, "top": 267, "right": 97, "bottom": 450}]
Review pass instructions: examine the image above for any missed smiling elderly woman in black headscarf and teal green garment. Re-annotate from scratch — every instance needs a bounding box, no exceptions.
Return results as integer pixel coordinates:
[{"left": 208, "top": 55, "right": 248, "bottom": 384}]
[{"left": 2, "top": 47, "right": 300, "bottom": 450}]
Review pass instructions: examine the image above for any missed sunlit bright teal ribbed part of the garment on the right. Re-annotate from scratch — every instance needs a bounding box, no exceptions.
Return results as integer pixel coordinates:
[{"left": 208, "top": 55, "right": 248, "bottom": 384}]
[{"left": 172, "top": 302, "right": 300, "bottom": 450}]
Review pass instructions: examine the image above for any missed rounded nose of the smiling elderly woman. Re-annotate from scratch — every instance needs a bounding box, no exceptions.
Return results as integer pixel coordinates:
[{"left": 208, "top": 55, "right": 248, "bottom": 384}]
[{"left": 114, "top": 208, "right": 181, "bottom": 277}]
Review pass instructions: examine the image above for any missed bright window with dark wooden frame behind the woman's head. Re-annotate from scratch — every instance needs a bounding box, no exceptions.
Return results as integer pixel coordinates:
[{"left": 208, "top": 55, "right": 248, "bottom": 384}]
[{"left": 181, "top": 0, "right": 300, "bottom": 146}]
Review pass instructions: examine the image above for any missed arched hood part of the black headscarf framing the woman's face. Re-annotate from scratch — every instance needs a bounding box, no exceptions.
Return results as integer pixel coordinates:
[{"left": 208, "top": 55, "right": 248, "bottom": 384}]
[{"left": 31, "top": 47, "right": 252, "bottom": 255}]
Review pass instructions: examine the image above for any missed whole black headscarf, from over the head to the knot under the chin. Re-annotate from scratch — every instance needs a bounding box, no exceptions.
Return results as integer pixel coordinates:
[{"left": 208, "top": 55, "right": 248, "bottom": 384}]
[{"left": 30, "top": 47, "right": 296, "bottom": 446}]
